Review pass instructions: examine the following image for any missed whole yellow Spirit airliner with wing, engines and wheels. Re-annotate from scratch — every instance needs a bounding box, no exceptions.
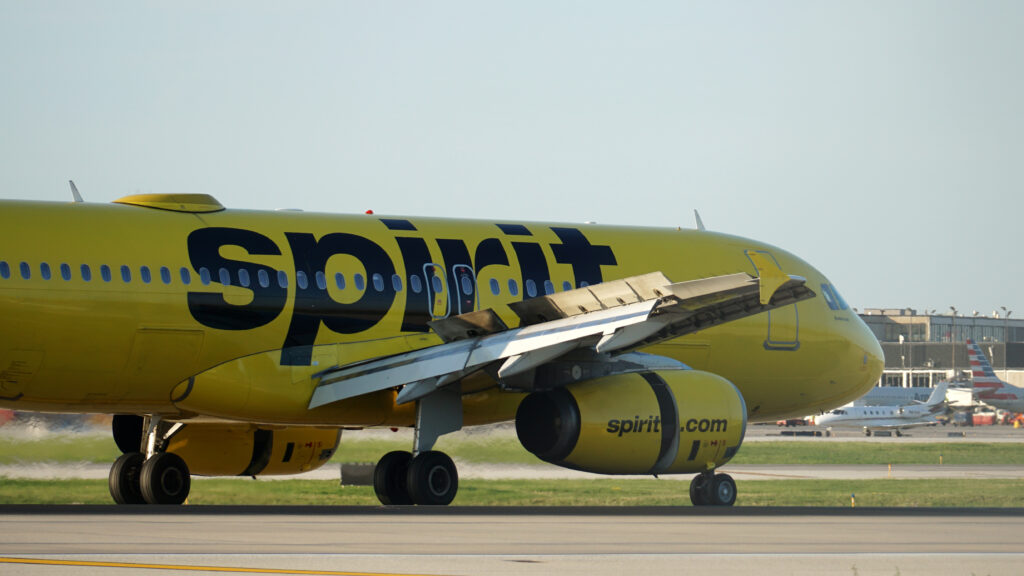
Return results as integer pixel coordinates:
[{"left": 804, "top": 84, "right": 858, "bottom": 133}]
[{"left": 0, "top": 195, "right": 883, "bottom": 504}]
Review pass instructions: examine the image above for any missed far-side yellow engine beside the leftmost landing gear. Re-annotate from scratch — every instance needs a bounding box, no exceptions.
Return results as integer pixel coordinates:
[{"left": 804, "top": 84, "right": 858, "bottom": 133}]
[{"left": 167, "top": 424, "right": 341, "bottom": 476}]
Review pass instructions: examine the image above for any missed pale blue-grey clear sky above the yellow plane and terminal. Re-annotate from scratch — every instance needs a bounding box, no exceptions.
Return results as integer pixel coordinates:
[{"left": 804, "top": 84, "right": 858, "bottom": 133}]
[{"left": 0, "top": 0, "right": 1024, "bottom": 317}]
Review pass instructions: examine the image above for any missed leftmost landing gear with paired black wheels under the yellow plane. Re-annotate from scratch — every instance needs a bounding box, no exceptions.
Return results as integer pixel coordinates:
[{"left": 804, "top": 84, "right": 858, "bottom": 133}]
[{"left": 109, "top": 415, "right": 191, "bottom": 504}]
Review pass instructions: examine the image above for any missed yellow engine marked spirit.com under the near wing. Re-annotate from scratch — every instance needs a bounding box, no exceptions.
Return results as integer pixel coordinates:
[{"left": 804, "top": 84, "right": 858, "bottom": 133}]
[{"left": 515, "top": 370, "right": 746, "bottom": 475}]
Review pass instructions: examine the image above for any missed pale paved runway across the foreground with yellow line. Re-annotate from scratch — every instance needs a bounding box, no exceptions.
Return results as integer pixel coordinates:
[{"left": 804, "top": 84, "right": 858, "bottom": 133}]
[{"left": 0, "top": 506, "right": 1024, "bottom": 576}]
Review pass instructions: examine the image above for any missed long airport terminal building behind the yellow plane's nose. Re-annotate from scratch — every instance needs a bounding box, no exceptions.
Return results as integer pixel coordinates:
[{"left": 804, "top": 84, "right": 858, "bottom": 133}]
[{"left": 859, "top": 308, "right": 1024, "bottom": 387}]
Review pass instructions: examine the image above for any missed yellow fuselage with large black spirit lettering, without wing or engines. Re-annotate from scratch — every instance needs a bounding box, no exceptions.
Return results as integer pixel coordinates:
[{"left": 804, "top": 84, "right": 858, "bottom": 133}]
[{"left": 0, "top": 198, "right": 882, "bottom": 426}]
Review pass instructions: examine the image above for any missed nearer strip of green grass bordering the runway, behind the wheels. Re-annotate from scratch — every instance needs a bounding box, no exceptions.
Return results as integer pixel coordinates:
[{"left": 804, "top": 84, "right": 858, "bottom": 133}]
[{"left": 0, "top": 479, "right": 1024, "bottom": 507}]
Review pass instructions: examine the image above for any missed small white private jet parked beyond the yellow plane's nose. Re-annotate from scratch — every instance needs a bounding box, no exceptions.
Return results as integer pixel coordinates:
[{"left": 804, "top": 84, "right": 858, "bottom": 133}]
[{"left": 814, "top": 382, "right": 948, "bottom": 436}]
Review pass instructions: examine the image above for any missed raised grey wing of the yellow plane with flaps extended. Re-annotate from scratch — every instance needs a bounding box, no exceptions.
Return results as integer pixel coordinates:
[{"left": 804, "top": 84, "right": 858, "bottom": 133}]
[{"left": 309, "top": 259, "right": 815, "bottom": 409}]
